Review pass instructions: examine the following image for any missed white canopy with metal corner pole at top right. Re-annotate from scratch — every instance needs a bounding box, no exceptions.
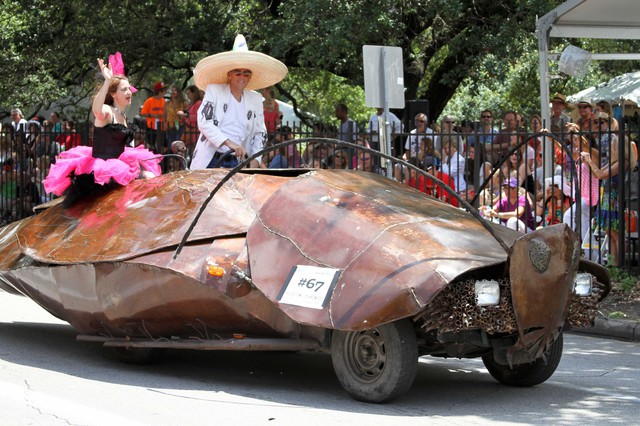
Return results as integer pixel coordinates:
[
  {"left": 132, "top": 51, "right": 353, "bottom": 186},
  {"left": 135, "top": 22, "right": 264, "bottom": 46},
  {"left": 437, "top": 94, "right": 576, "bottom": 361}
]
[{"left": 536, "top": 0, "right": 640, "bottom": 172}]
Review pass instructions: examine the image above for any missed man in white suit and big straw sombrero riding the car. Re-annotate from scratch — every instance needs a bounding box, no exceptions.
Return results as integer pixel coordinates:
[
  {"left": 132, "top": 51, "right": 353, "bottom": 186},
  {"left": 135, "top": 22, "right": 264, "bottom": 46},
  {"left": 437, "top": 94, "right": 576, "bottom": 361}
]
[{"left": 191, "top": 34, "right": 287, "bottom": 170}]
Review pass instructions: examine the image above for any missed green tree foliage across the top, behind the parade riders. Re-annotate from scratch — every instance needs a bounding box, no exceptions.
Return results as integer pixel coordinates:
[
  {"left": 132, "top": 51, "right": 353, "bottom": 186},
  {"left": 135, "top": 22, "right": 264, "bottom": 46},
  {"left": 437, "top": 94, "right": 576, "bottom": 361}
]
[{"left": 0, "top": 0, "right": 629, "bottom": 129}]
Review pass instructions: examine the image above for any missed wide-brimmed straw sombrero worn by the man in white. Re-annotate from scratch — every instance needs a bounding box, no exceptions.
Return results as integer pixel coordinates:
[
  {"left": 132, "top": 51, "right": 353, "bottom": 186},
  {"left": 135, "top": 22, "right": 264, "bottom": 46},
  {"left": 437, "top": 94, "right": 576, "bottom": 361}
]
[{"left": 193, "top": 34, "right": 287, "bottom": 90}]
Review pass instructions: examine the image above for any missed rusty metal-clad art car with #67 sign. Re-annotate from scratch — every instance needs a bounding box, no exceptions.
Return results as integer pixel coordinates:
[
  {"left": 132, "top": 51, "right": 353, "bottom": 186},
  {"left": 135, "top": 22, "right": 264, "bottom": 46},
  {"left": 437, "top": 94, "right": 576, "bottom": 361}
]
[{"left": 0, "top": 162, "right": 610, "bottom": 402}]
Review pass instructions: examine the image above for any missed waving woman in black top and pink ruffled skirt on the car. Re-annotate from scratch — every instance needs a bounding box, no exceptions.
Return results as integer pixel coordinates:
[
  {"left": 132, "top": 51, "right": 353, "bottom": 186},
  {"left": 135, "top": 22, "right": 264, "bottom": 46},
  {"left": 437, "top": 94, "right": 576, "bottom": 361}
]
[{"left": 44, "top": 59, "right": 161, "bottom": 207}]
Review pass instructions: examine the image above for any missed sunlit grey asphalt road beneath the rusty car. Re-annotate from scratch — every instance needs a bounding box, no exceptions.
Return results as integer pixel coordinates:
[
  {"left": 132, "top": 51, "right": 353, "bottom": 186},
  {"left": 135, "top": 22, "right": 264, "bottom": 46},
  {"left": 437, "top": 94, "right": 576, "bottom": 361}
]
[{"left": 0, "top": 291, "right": 640, "bottom": 426}]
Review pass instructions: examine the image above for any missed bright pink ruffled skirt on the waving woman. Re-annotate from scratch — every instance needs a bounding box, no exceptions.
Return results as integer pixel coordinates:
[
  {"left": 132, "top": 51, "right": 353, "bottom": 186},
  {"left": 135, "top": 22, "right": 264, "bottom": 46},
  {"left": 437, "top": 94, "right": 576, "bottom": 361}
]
[{"left": 43, "top": 145, "right": 162, "bottom": 195}]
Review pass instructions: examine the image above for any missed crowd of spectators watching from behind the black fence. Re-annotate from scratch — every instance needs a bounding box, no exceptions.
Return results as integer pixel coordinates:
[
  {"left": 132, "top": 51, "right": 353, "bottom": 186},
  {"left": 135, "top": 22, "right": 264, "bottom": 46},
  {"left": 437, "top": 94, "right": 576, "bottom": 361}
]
[{"left": 0, "top": 92, "right": 637, "bottom": 266}]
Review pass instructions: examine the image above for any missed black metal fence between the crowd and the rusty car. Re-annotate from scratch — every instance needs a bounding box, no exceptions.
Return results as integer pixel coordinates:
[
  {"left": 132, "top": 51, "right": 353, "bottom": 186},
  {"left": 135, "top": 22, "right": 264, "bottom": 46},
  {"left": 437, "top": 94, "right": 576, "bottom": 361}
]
[{"left": 0, "top": 120, "right": 640, "bottom": 274}]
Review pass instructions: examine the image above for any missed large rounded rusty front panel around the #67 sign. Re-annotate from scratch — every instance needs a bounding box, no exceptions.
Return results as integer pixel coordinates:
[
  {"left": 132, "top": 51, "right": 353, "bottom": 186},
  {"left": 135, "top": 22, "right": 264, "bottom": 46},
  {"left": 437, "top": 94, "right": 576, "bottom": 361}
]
[{"left": 247, "top": 171, "right": 520, "bottom": 330}]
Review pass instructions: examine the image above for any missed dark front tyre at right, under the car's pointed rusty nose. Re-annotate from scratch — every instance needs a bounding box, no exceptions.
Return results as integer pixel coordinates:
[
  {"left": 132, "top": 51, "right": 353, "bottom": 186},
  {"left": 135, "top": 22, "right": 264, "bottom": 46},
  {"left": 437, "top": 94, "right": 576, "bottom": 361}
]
[{"left": 482, "top": 333, "right": 563, "bottom": 387}]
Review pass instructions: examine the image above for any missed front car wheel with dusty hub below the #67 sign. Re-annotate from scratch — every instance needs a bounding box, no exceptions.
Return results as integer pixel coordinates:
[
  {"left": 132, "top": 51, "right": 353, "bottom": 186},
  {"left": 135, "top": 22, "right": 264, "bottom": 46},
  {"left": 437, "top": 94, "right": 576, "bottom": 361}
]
[{"left": 331, "top": 320, "right": 418, "bottom": 403}]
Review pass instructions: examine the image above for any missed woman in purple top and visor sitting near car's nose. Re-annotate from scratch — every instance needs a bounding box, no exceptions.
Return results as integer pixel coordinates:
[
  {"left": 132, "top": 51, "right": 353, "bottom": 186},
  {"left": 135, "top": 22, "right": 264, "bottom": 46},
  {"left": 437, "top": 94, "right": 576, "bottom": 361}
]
[{"left": 483, "top": 177, "right": 535, "bottom": 234}]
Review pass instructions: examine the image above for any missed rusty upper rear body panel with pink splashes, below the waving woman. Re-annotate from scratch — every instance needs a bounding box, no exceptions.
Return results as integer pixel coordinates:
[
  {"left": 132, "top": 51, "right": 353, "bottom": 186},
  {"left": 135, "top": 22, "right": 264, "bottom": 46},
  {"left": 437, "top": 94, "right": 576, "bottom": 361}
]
[{"left": 17, "top": 170, "right": 287, "bottom": 264}]
